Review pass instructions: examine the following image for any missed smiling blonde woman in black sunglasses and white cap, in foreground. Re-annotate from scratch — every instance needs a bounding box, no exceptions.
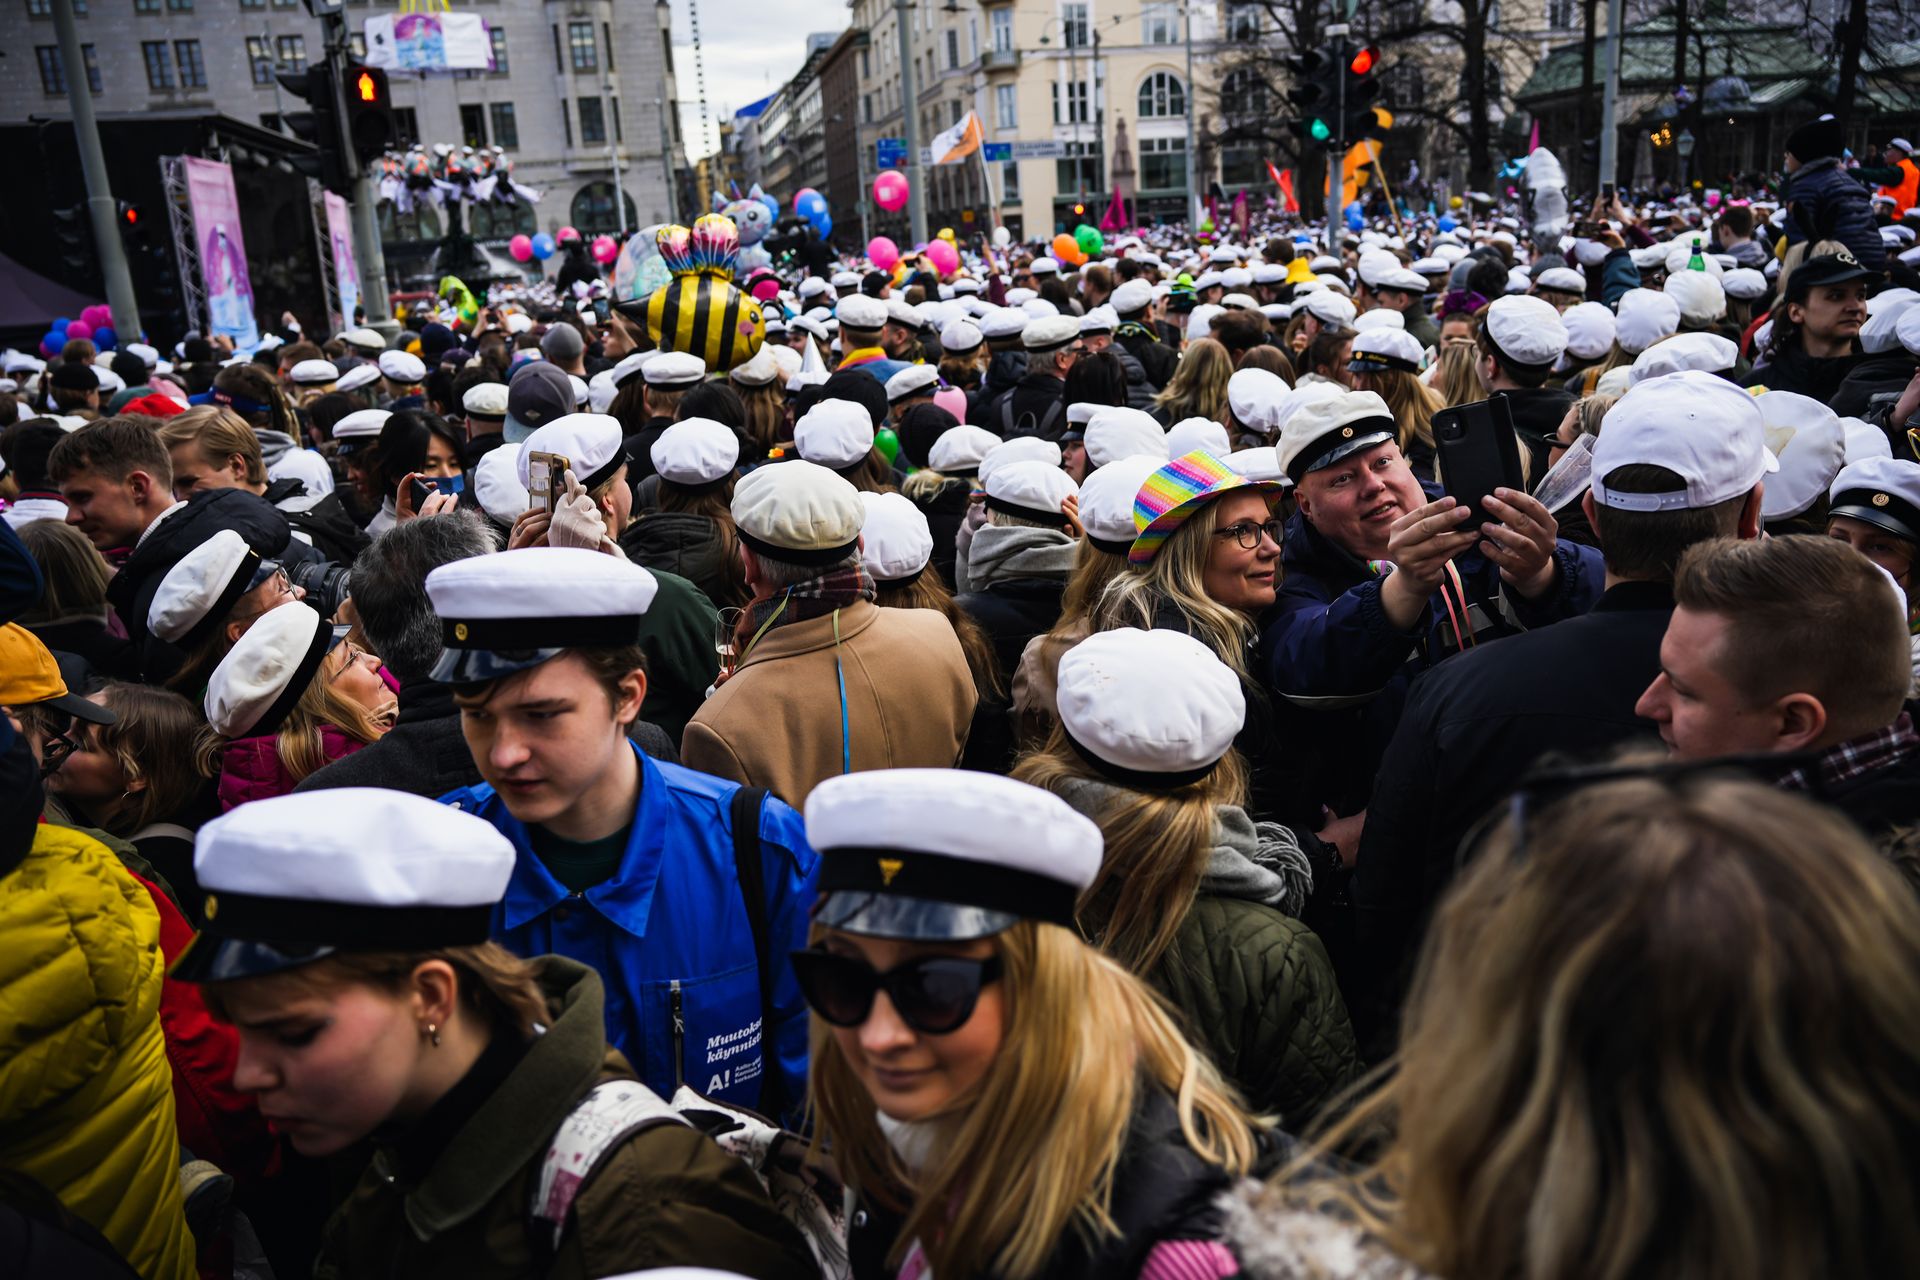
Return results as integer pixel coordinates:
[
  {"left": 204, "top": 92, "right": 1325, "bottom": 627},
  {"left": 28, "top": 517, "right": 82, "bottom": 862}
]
[{"left": 793, "top": 770, "right": 1265, "bottom": 1280}]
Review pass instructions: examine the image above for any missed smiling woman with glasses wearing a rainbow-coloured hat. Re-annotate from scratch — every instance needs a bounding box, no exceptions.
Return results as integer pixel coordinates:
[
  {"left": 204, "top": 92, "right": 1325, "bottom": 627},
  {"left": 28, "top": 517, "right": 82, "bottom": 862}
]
[{"left": 1092, "top": 453, "right": 1319, "bottom": 825}]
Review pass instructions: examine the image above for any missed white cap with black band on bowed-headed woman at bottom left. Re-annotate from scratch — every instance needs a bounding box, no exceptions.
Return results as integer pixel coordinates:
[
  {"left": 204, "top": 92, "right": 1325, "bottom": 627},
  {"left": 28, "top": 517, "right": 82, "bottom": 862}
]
[{"left": 171, "top": 787, "right": 513, "bottom": 983}]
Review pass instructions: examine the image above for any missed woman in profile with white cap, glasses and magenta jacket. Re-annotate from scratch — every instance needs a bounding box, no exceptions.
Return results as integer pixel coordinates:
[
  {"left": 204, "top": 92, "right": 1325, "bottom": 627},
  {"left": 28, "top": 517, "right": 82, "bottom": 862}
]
[{"left": 205, "top": 603, "right": 399, "bottom": 810}]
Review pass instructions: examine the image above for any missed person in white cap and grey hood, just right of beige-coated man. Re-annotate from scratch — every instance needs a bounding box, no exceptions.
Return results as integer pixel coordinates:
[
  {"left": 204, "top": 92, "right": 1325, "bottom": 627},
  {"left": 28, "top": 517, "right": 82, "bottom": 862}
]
[{"left": 954, "top": 458, "right": 1079, "bottom": 687}]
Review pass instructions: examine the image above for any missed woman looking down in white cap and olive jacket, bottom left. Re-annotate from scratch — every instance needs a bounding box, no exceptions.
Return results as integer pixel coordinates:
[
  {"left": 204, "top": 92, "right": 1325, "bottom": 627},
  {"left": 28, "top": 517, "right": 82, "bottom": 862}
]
[{"left": 173, "top": 787, "right": 818, "bottom": 1280}]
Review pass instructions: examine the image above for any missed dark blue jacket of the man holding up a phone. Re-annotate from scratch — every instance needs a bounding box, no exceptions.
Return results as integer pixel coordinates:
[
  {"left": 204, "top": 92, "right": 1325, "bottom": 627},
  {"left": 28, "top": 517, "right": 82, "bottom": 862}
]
[{"left": 1254, "top": 482, "right": 1607, "bottom": 814}]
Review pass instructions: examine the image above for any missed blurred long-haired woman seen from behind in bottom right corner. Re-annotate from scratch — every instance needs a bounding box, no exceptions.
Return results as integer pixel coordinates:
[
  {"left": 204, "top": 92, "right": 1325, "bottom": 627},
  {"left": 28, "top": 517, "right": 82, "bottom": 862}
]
[{"left": 1231, "top": 764, "right": 1920, "bottom": 1280}]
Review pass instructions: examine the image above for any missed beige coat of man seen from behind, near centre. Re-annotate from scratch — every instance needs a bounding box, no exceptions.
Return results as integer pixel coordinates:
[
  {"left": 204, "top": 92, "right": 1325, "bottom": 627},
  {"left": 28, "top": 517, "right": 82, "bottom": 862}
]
[{"left": 680, "top": 601, "right": 975, "bottom": 808}]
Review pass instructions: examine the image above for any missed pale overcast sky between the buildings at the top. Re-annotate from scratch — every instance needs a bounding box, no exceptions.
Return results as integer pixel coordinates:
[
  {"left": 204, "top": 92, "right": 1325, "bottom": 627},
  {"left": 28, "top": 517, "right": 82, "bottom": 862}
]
[{"left": 672, "top": 0, "right": 849, "bottom": 159}]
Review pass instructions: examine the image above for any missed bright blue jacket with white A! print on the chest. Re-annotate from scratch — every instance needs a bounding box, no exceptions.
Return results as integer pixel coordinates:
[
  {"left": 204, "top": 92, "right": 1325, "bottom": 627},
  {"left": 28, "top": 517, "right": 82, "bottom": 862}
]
[{"left": 442, "top": 747, "right": 820, "bottom": 1107}]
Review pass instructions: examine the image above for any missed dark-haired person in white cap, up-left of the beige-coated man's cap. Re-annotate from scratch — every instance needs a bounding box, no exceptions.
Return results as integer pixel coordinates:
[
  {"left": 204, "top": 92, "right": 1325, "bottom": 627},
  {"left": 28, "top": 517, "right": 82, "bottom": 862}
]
[{"left": 620, "top": 418, "right": 747, "bottom": 608}]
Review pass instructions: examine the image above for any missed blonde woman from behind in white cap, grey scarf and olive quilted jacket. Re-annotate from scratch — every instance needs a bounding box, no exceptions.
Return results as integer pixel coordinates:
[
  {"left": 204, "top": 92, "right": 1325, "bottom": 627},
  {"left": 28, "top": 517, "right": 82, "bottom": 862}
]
[{"left": 1014, "top": 628, "right": 1361, "bottom": 1132}]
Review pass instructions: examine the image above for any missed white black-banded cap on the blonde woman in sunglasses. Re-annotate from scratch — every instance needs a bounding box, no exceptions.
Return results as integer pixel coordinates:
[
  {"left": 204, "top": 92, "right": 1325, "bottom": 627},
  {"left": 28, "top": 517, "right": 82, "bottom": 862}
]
[{"left": 806, "top": 770, "right": 1102, "bottom": 942}]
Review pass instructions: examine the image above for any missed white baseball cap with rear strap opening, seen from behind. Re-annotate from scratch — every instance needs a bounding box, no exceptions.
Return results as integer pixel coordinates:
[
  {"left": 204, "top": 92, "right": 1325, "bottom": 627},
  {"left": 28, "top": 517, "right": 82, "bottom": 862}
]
[{"left": 1594, "top": 368, "right": 1780, "bottom": 510}]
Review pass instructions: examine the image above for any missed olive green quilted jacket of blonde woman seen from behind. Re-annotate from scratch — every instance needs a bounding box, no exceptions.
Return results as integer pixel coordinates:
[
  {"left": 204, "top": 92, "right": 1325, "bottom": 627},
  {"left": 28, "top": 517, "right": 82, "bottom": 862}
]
[{"left": 1146, "top": 887, "right": 1361, "bottom": 1132}]
